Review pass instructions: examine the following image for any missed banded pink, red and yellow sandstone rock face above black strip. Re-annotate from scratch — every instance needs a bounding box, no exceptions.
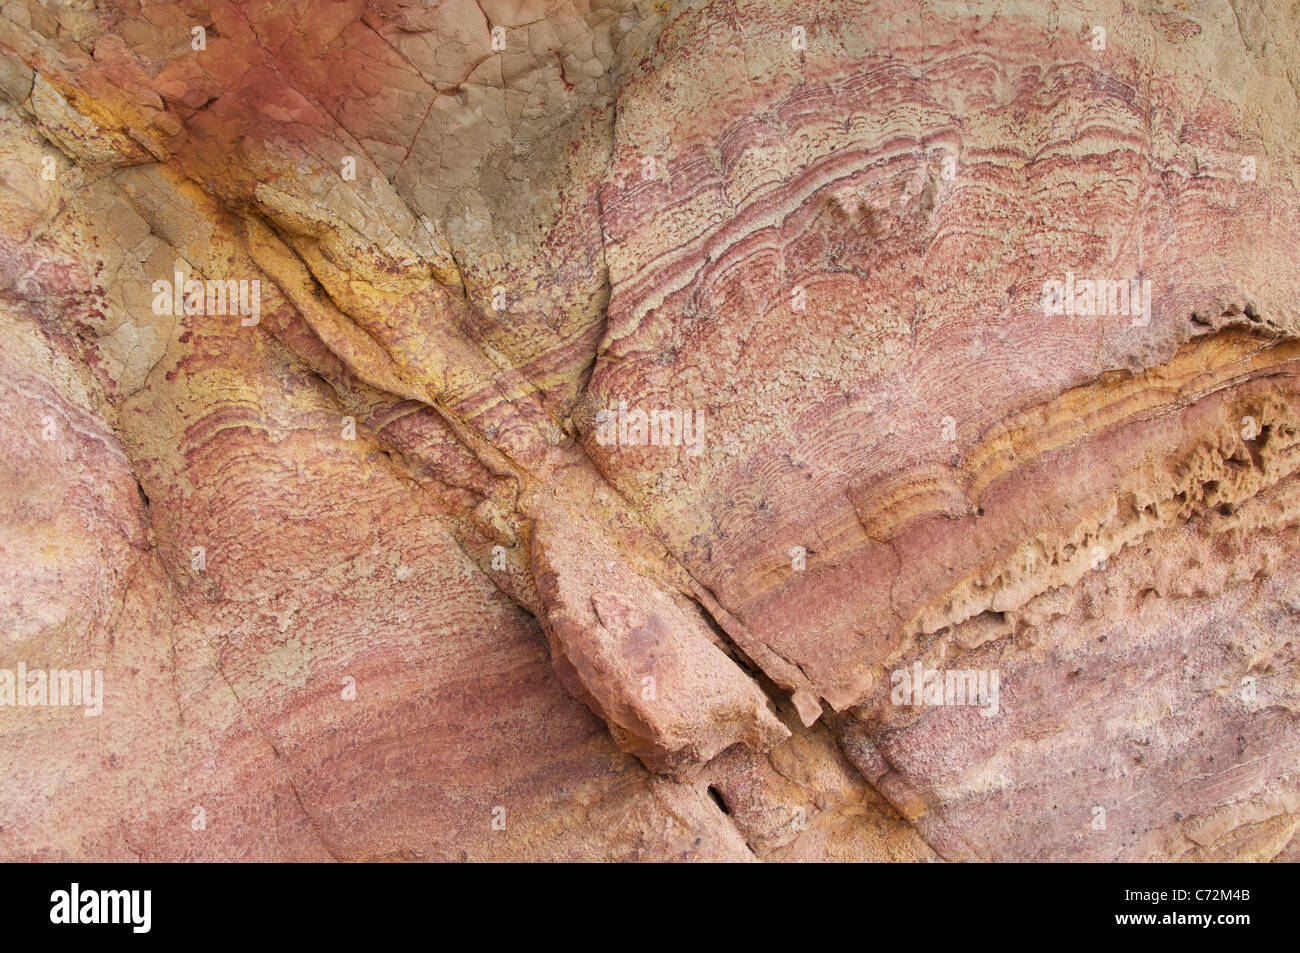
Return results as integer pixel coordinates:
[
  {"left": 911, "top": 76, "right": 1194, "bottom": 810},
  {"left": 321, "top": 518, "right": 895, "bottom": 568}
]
[{"left": 0, "top": 0, "right": 1300, "bottom": 861}]
